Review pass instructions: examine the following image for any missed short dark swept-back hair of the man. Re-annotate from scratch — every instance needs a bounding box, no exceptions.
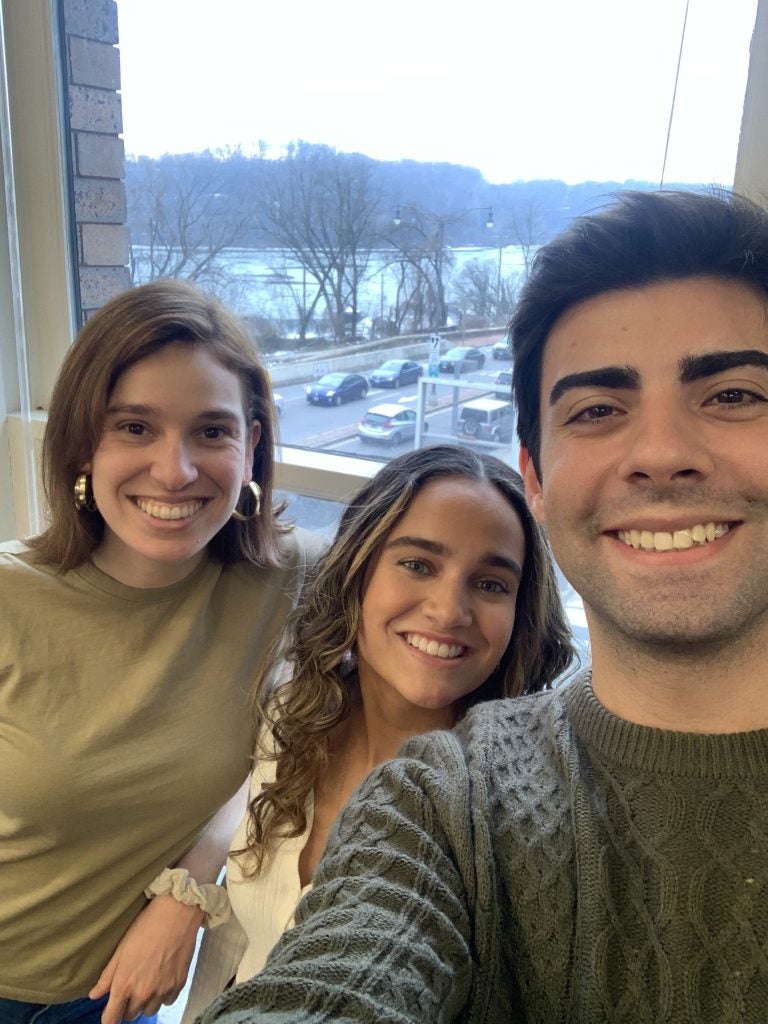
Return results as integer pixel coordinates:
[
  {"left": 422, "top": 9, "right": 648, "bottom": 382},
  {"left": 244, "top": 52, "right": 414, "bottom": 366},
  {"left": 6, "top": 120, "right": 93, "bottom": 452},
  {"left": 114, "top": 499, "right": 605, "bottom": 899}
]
[{"left": 510, "top": 191, "right": 768, "bottom": 475}]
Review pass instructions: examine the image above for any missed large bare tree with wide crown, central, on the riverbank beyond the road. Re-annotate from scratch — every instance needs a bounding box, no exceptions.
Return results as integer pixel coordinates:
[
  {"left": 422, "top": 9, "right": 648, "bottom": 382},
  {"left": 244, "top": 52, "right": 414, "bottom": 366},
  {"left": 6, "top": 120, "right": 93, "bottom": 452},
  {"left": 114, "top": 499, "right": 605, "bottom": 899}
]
[{"left": 256, "top": 142, "right": 380, "bottom": 340}]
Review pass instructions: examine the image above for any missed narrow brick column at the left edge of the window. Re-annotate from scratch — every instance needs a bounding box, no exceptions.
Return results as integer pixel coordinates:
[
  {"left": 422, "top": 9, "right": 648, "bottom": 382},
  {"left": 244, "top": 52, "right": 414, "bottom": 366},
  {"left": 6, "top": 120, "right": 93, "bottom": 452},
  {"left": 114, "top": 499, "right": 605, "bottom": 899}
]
[{"left": 62, "top": 0, "right": 130, "bottom": 319}]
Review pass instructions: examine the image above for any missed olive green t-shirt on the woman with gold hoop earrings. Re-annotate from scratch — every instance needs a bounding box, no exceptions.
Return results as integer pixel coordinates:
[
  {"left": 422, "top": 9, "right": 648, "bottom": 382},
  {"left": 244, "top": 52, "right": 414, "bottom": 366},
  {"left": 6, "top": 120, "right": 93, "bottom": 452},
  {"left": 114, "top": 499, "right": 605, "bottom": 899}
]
[{"left": 0, "top": 531, "right": 314, "bottom": 1002}]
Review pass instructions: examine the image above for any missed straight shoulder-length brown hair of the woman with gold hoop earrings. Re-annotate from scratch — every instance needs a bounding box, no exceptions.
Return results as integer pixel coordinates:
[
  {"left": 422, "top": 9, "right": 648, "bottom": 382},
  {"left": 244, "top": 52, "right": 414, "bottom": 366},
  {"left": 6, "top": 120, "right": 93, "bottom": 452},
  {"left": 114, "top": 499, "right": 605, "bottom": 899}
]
[{"left": 27, "top": 279, "right": 286, "bottom": 572}]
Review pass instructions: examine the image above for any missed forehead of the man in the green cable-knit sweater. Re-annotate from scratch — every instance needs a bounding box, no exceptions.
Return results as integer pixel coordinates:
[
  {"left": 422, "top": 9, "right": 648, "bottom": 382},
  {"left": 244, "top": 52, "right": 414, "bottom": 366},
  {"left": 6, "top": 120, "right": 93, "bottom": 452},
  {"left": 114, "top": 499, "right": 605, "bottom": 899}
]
[{"left": 542, "top": 278, "right": 768, "bottom": 389}]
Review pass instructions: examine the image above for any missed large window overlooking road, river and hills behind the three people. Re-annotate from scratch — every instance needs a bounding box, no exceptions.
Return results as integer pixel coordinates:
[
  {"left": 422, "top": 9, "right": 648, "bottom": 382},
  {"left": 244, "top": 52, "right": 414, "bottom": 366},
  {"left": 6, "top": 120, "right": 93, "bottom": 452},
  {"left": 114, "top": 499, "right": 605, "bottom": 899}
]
[{"left": 112, "top": 0, "right": 756, "bottom": 483}]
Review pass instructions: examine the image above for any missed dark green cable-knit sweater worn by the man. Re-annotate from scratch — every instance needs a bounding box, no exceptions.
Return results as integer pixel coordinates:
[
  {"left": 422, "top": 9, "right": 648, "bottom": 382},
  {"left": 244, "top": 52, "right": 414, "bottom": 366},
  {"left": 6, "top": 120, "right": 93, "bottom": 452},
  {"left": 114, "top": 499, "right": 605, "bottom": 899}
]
[{"left": 203, "top": 676, "right": 768, "bottom": 1024}]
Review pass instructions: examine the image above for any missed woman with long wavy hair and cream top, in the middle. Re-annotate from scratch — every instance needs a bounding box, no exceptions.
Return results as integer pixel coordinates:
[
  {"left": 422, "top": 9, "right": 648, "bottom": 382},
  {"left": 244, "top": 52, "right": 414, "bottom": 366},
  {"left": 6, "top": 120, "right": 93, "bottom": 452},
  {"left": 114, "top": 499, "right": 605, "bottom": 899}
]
[{"left": 187, "top": 445, "right": 573, "bottom": 1017}]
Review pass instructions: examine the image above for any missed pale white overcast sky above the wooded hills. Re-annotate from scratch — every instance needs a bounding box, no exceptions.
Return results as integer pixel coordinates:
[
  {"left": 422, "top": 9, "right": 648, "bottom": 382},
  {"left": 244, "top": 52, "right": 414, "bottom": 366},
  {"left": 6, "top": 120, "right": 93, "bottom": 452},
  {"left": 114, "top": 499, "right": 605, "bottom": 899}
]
[{"left": 118, "top": 0, "right": 757, "bottom": 185}]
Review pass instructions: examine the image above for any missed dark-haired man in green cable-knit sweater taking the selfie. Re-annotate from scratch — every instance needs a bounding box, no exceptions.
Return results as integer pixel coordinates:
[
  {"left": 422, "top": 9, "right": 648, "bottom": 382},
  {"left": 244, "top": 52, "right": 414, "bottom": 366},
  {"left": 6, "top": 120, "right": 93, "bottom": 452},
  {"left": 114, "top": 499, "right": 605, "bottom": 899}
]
[{"left": 203, "top": 193, "right": 768, "bottom": 1024}]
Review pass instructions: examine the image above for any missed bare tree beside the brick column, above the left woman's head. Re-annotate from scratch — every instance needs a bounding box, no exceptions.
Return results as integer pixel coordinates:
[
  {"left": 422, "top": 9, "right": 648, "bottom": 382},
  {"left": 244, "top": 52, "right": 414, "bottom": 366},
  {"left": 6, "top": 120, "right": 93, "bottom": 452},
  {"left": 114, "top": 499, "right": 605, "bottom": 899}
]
[{"left": 126, "top": 153, "right": 252, "bottom": 291}]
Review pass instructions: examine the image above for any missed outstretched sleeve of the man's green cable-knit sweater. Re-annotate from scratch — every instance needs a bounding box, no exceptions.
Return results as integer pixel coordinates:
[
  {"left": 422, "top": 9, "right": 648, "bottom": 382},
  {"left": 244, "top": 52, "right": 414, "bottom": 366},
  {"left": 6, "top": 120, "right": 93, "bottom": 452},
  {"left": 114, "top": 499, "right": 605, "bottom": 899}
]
[{"left": 202, "top": 733, "right": 473, "bottom": 1024}]
